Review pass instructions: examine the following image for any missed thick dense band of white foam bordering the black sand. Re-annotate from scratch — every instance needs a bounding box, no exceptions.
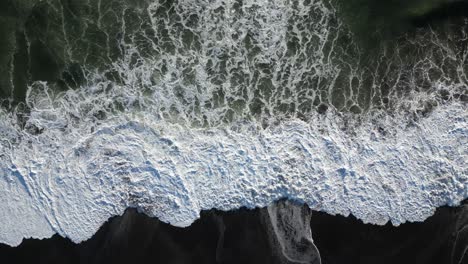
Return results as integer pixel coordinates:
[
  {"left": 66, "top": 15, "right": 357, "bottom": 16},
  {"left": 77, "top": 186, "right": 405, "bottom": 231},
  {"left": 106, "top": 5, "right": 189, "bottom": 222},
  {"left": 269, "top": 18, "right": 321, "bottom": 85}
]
[{"left": 0, "top": 97, "right": 468, "bottom": 245}]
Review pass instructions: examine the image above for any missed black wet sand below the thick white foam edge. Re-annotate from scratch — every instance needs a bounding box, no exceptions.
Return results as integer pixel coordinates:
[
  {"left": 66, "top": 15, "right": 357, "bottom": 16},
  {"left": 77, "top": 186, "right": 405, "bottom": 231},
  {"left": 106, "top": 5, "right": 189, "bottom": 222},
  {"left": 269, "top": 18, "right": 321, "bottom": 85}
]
[{"left": 0, "top": 202, "right": 468, "bottom": 264}]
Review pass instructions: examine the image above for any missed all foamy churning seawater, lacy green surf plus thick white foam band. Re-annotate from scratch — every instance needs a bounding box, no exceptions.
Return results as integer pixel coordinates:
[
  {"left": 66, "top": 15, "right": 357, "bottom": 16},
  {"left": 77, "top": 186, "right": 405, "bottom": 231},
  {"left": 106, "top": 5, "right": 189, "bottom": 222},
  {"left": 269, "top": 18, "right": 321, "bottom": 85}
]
[{"left": 0, "top": 0, "right": 468, "bottom": 245}]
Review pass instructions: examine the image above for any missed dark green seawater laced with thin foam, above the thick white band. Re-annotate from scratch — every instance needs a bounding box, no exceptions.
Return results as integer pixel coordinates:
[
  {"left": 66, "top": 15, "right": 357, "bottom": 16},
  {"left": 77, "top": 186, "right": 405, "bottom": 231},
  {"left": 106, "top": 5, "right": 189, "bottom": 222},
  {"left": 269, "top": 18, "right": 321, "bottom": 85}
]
[{"left": 0, "top": 0, "right": 466, "bottom": 125}]
